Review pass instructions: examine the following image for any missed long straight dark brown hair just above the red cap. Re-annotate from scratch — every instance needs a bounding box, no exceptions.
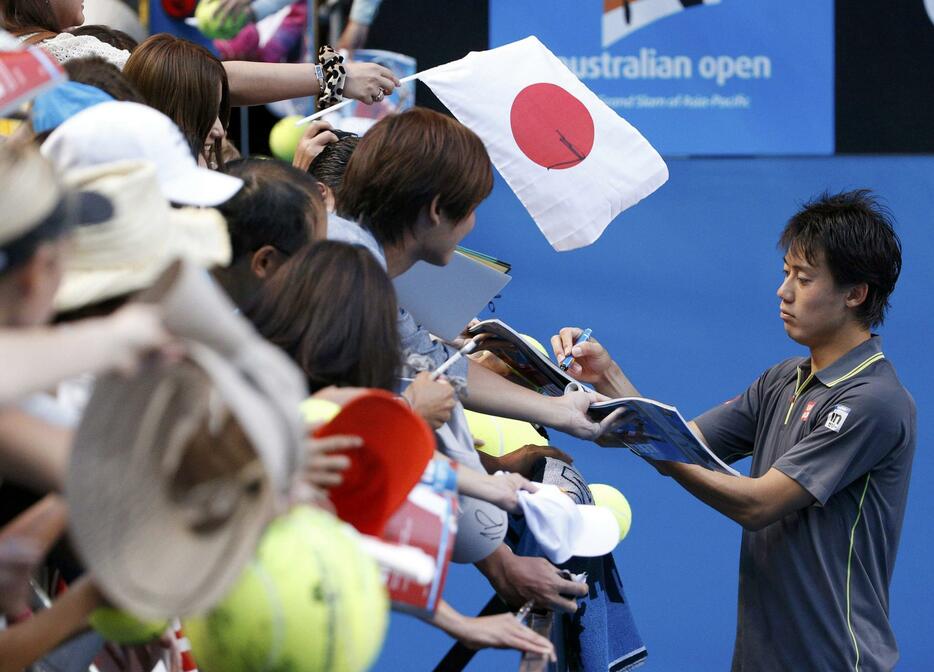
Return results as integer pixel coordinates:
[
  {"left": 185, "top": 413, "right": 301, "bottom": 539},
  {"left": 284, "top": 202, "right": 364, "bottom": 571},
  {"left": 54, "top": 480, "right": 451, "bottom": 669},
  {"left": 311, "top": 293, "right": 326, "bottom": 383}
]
[{"left": 248, "top": 240, "right": 401, "bottom": 391}]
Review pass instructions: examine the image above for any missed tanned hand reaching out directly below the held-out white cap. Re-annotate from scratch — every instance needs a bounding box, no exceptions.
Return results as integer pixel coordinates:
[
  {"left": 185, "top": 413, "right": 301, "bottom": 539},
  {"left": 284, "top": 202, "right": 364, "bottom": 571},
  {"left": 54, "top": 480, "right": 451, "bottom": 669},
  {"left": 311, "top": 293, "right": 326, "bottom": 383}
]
[{"left": 477, "top": 546, "right": 589, "bottom": 614}]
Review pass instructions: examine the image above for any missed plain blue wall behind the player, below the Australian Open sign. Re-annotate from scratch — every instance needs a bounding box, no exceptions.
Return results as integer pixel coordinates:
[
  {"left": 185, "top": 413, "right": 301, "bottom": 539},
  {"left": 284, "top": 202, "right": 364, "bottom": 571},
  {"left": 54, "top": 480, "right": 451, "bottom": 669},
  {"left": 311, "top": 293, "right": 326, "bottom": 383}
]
[{"left": 375, "top": 157, "right": 934, "bottom": 672}]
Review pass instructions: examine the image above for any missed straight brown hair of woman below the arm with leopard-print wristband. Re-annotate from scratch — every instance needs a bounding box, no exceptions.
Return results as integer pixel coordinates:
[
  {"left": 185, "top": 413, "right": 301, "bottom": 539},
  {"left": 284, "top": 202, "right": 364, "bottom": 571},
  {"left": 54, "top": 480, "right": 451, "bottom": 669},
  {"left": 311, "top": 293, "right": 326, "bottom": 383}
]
[{"left": 123, "top": 33, "right": 230, "bottom": 163}]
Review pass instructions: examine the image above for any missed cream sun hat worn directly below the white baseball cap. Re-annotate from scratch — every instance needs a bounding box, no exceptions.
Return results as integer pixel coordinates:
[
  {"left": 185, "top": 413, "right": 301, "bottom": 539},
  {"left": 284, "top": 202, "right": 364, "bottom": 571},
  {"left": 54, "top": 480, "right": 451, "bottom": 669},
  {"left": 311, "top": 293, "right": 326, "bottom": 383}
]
[{"left": 55, "top": 161, "right": 230, "bottom": 311}]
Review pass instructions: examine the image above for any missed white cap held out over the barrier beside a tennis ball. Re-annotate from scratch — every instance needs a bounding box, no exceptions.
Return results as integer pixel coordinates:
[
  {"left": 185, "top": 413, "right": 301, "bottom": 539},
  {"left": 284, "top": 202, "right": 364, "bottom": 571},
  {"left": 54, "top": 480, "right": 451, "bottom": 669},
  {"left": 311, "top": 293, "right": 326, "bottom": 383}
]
[{"left": 519, "top": 485, "right": 619, "bottom": 565}]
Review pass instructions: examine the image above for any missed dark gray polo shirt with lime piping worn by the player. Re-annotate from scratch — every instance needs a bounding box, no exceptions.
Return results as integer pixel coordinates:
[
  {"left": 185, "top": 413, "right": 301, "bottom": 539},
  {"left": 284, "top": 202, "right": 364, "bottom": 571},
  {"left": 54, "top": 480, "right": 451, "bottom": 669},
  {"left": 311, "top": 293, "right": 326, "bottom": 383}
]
[{"left": 696, "top": 336, "right": 916, "bottom": 672}]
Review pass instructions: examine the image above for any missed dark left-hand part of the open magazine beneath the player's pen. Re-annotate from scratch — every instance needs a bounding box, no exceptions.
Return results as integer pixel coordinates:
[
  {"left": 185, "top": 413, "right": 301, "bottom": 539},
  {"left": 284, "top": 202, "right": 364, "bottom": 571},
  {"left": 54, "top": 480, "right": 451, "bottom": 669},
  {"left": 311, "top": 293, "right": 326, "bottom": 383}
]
[{"left": 469, "top": 320, "right": 574, "bottom": 397}]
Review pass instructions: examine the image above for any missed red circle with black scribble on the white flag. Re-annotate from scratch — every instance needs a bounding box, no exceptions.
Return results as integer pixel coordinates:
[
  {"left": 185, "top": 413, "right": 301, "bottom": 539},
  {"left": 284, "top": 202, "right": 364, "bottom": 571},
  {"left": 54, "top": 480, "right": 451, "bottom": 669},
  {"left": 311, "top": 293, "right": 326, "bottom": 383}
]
[{"left": 509, "top": 83, "right": 594, "bottom": 170}]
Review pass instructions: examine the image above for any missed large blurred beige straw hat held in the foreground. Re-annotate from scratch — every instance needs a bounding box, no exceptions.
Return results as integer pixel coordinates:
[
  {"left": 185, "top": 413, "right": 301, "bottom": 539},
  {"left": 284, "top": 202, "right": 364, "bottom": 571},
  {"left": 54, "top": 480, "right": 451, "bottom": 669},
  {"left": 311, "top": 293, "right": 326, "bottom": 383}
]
[{"left": 65, "top": 263, "right": 307, "bottom": 618}]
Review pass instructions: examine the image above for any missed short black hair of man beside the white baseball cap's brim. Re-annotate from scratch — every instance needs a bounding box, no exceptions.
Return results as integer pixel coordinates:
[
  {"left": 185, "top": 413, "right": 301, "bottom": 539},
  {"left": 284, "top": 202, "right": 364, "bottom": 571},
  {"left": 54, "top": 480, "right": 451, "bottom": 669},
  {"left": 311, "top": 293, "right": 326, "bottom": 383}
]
[{"left": 218, "top": 158, "right": 327, "bottom": 265}]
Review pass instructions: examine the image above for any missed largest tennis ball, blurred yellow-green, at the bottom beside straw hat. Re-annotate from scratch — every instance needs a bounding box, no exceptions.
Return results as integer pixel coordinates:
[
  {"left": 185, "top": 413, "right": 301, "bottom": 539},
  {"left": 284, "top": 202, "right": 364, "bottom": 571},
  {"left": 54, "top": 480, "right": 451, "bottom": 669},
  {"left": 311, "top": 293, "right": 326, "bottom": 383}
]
[{"left": 183, "top": 507, "right": 389, "bottom": 672}]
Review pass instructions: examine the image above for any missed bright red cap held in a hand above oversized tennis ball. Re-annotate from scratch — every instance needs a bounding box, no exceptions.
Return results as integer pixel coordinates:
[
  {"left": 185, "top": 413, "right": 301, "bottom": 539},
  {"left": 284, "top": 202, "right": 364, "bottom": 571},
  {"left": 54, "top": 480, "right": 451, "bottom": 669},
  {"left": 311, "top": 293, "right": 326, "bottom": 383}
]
[{"left": 314, "top": 390, "right": 435, "bottom": 535}]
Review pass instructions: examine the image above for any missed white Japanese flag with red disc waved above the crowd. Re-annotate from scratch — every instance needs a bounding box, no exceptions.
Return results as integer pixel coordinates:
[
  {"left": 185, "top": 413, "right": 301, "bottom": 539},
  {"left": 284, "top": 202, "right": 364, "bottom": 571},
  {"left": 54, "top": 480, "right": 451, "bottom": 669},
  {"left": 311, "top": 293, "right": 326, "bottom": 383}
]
[{"left": 418, "top": 36, "right": 668, "bottom": 251}]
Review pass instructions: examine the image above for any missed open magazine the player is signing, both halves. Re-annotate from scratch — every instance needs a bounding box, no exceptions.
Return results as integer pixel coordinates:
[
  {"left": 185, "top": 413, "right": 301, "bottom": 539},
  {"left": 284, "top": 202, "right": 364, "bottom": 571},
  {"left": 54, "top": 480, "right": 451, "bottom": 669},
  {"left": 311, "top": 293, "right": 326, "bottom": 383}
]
[{"left": 469, "top": 320, "right": 739, "bottom": 476}]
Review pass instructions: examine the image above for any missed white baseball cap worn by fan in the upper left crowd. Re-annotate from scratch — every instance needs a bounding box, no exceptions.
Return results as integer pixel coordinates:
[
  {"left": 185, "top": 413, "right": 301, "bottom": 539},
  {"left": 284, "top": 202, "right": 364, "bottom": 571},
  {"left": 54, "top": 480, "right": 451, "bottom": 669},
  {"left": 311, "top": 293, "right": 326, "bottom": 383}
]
[{"left": 41, "top": 101, "right": 243, "bottom": 207}]
